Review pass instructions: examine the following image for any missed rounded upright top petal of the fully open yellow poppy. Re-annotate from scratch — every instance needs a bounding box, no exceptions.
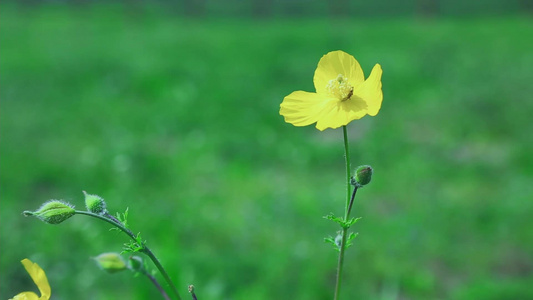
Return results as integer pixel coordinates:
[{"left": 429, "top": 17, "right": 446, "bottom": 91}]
[{"left": 313, "top": 50, "right": 365, "bottom": 94}]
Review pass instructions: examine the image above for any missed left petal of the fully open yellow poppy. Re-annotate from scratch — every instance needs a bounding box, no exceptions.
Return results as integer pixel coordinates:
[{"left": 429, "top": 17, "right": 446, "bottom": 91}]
[{"left": 279, "top": 91, "right": 336, "bottom": 126}]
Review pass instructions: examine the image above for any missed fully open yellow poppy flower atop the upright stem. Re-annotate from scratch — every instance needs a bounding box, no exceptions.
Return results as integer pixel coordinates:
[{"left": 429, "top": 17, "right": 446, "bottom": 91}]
[{"left": 279, "top": 51, "right": 383, "bottom": 130}]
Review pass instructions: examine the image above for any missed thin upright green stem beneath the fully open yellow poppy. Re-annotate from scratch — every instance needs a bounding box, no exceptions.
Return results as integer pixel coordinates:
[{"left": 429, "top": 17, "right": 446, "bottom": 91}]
[{"left": 333, "top": 126, "right": 357, "bottom": 300}]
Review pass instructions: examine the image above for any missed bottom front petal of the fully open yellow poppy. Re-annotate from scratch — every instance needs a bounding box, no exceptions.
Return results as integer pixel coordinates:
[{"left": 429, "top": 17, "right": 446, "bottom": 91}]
[{"left": 316, "top": 96, "right": 367, "bottom": 131}]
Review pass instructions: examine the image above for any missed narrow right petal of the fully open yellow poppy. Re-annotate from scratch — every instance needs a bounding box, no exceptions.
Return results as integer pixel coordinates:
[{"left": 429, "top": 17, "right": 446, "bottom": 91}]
[{"left": 353, "top": 64, "right": 383, "bottom": 116}]
